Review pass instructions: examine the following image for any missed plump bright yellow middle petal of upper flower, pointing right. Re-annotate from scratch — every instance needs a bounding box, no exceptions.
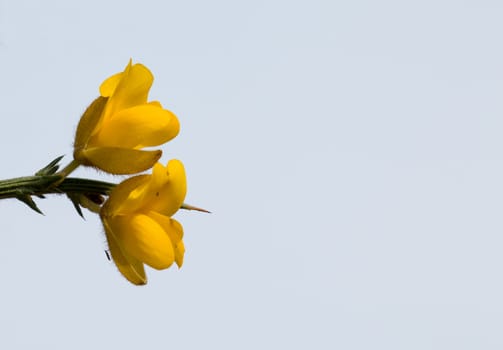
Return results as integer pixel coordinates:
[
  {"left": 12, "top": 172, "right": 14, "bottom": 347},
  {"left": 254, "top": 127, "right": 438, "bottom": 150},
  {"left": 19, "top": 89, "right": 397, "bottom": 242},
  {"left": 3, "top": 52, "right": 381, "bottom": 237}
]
[{"left": 89, "top": 104, "right": 180, "bottom": 149}]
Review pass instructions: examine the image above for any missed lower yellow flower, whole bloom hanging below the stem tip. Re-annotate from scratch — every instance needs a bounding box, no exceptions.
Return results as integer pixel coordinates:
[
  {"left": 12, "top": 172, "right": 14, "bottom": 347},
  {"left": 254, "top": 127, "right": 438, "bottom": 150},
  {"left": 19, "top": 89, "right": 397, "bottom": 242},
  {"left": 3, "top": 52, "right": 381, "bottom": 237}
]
[{"left": 100, "top": 160, "right": 187, "bottom": 285}]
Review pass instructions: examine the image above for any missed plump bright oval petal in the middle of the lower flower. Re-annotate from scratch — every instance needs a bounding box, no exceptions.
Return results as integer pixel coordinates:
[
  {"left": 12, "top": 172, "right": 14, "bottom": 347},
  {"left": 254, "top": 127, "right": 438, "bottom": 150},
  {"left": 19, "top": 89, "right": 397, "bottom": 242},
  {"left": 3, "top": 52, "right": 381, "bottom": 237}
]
[{"left": 108, "top": 214, "right": 175, "bottom": 270}]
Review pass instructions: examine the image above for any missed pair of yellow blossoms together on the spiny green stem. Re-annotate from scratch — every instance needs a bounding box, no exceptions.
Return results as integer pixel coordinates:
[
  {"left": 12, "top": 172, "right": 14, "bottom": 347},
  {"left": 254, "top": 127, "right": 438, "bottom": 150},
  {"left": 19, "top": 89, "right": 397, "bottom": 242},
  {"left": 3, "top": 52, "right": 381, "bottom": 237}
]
[{"left": 73, "top": 61, "right": 193, "bottom": 285}]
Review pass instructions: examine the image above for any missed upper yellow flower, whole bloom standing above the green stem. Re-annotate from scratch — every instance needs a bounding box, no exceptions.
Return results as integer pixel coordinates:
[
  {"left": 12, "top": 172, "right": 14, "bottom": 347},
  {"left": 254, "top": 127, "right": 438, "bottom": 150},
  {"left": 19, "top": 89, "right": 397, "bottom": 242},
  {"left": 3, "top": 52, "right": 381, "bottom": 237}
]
[{"left": 73, "top": 61, "right": 180, "bottom": 174}]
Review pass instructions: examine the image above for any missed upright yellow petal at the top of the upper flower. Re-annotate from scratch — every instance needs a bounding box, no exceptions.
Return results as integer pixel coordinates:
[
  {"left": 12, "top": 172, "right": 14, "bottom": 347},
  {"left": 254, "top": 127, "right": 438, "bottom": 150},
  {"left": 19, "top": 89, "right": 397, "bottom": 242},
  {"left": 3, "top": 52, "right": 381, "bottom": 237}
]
[{"left": 103, "top": 62, "right": 154, "bottom": 118}]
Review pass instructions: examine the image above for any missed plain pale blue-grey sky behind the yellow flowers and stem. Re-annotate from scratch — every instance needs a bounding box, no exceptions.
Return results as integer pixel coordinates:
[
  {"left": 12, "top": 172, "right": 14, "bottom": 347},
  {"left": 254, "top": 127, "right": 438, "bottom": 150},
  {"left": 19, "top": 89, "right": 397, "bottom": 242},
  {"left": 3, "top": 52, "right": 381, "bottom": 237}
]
[{"left": 0, "top": 0, "right": 503, "bottom": 350}]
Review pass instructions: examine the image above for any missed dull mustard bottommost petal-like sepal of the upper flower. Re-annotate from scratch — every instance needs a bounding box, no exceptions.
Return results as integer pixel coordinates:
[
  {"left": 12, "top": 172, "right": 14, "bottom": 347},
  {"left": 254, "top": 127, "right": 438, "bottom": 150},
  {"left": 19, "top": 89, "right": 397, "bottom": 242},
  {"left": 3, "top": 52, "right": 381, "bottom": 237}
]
[{"left": 79, "top": 147, "right": 162, "bottom": 175}]
